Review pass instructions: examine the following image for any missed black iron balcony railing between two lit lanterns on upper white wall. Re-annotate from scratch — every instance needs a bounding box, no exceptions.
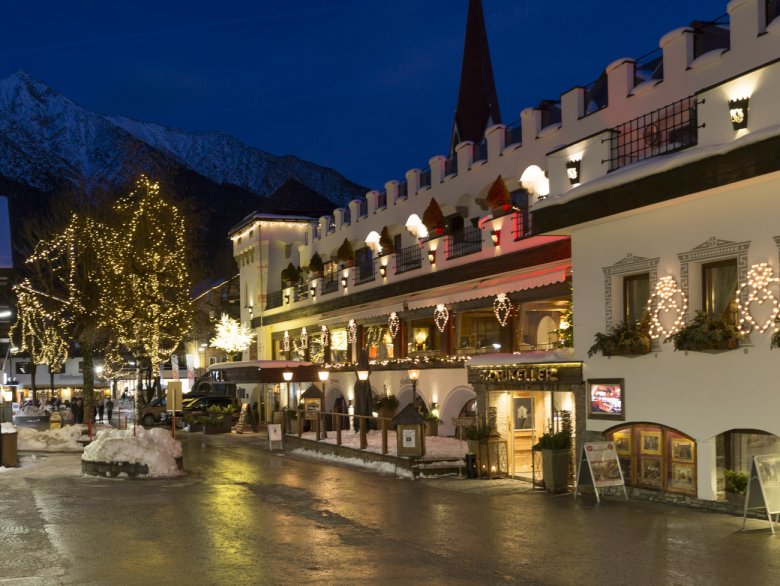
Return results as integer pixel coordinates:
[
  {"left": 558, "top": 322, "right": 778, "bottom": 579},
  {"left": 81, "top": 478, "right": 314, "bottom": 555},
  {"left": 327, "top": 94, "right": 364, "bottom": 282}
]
[{"left": 605, "top": 96, "right": 698, "bottom": 171}]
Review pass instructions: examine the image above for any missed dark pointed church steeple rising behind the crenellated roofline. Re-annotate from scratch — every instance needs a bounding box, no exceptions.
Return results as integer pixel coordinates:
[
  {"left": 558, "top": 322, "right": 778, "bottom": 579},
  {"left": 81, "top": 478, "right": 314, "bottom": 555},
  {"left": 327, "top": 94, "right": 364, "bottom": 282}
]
[{"left": 450, "top": 0, "right": 501, "bottom": 154}]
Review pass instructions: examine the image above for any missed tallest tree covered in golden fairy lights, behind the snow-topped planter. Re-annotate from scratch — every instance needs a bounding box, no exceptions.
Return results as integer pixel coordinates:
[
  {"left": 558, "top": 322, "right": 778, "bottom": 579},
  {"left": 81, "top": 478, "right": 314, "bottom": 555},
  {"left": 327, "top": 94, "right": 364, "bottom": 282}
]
[{"left": 103, "top": 176, "right": 192, "bottom": 398}]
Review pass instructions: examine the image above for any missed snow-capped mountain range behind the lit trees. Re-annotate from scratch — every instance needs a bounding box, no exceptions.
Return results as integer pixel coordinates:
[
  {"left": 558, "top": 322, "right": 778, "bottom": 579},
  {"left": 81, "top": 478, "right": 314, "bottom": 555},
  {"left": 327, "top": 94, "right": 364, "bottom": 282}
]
[{"left": 0, "top": 71, "right": 366, "bottom": 205}]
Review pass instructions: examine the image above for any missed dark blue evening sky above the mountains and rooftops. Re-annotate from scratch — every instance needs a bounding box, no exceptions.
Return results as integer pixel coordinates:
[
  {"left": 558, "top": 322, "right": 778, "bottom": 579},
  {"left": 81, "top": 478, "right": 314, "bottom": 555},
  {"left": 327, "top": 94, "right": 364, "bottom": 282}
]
[{"left": 0, "top": 0, "right": 727, "bottom": 188}]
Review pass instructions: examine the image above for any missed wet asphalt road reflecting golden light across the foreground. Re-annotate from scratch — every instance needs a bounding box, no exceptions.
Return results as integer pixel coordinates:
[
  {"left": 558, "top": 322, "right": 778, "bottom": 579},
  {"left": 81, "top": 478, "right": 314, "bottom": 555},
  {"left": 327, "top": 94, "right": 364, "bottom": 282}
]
[{"left": 0, "top": 434, "right": 780, "bottom": 585}]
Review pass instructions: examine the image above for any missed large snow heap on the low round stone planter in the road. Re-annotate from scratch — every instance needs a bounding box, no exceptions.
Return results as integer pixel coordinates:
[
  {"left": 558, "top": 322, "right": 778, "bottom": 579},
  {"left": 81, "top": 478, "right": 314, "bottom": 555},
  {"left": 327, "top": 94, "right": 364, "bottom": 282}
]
[{"left": 81, "top": 427, "right": 181, "bottom": 478}]
